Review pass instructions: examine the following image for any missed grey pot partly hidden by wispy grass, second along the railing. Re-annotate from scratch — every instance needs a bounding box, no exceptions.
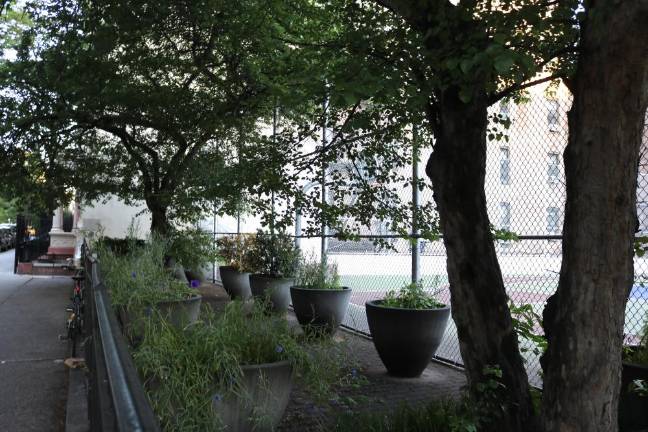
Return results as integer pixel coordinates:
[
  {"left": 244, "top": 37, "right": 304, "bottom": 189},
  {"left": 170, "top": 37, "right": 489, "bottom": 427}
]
[{"left": 118, "top": 294, "right": 202, "bottom": 341}]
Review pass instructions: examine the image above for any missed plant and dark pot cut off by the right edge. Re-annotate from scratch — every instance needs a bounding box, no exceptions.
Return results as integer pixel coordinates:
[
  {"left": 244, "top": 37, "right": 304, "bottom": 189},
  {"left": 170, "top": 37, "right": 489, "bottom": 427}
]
[{"left": 619, "top": 315, "right": 648, "bottom": 432}]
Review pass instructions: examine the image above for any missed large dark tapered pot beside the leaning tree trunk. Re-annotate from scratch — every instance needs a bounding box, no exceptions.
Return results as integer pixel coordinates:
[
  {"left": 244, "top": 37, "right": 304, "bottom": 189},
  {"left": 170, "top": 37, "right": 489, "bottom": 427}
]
[{"left": 366, "top": 300, "right": 450, "bottom": 378}]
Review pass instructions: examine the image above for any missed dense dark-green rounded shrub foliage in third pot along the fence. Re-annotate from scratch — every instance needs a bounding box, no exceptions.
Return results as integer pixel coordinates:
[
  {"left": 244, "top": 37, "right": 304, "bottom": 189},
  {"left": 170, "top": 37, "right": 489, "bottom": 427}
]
[{"left": 250, "top": 231, "right": 301, "bottom": 277}]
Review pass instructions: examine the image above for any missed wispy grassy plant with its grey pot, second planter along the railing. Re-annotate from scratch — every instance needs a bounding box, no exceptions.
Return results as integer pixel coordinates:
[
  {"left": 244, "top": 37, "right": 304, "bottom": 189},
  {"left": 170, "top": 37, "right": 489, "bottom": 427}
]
[{"left": 97, "top": 238, "right": 202, "bottom": 340}]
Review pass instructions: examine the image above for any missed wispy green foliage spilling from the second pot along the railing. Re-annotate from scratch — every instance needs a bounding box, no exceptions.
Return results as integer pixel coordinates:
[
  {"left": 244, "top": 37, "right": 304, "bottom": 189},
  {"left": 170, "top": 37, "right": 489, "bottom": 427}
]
[{"left": 95, "top": 237, "right": 194, "bottom": 314}]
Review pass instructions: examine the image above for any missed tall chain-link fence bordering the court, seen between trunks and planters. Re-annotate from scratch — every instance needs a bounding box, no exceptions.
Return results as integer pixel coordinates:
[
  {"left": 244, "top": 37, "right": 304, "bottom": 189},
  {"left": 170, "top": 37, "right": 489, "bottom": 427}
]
[{"left": 208, "top": 87, "right": 648, "bottom": 386}]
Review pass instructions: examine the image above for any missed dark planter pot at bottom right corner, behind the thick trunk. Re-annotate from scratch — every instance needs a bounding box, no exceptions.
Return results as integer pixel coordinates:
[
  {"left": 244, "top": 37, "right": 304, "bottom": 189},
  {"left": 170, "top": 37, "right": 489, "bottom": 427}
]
[{"left": 619, "top": 354, "right": 648, "bottom": 432}]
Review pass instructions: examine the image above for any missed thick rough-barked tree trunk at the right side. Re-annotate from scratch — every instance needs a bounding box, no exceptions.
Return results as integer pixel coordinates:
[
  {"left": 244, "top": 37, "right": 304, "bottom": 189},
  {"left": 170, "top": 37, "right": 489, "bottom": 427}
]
[{"left": 543, "top": 0, "right": 648, "bottom": 432}]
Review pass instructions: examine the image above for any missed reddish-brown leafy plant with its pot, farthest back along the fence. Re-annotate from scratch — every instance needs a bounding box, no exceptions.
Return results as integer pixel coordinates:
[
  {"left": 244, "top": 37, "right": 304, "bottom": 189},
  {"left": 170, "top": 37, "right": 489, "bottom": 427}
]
[{"left": 216, "top": 234, "right": 255, "bottom": 300}]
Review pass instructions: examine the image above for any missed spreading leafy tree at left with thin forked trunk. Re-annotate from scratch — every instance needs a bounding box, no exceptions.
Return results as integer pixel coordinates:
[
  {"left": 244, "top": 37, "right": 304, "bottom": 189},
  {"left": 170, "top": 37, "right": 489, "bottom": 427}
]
[{"left": 0, "top": 0, "right": 284, "bottom": 233}]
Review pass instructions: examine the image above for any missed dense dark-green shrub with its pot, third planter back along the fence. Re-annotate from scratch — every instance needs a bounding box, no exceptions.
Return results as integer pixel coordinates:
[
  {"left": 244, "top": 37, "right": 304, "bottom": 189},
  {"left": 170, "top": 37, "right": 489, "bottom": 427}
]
[{"left": 250, "top": 232, "right": 301, "bottom": 313}]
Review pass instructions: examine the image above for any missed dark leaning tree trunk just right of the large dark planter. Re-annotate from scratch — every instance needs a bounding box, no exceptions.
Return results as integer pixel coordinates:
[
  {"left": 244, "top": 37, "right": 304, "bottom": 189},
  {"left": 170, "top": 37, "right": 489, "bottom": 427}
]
[{"left": 426, "top": 88, "right": 534, "bottom": 431}]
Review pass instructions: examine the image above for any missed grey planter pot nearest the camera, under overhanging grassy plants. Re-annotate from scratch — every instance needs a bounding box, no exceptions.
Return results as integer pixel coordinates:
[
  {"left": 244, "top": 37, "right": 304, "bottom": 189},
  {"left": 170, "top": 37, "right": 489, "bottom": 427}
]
[{"left": 212, "top": 361, "right": 292, "bottom": 432}]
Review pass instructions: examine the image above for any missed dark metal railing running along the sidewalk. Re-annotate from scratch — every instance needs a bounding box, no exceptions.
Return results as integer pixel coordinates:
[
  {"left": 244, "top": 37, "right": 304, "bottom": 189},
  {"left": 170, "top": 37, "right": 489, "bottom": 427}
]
[{"left": 83, "top": 245, "right": 160, "bottom": 432}]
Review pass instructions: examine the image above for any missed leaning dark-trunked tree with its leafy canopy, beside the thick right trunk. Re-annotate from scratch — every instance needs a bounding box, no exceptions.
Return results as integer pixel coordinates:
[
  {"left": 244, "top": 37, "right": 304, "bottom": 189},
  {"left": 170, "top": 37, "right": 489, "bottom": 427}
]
[{"left": 260, "top": 0, "right": 578, "bottom": 430}]
